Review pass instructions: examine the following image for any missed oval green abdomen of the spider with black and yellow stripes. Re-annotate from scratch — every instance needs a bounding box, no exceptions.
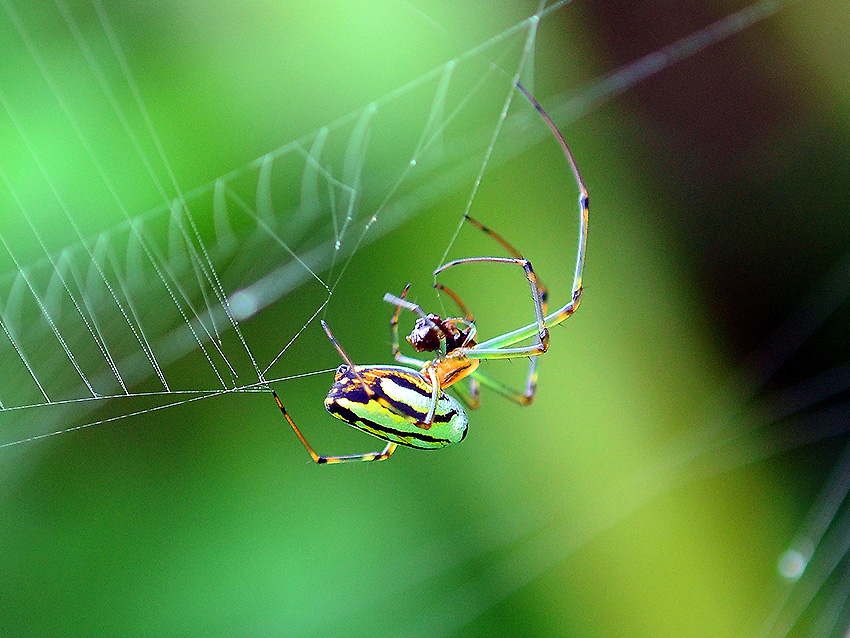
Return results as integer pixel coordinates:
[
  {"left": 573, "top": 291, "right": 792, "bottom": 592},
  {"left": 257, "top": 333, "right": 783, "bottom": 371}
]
[{"left": 325, "top": 365, "right": 468, "bottom": 450}]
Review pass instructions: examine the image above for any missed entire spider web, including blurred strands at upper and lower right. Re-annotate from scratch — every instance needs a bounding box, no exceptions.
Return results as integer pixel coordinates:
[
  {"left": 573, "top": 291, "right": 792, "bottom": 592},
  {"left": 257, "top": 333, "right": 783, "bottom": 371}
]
[{"left": 0, "top": 0, "right": 850, "bottom": 636}]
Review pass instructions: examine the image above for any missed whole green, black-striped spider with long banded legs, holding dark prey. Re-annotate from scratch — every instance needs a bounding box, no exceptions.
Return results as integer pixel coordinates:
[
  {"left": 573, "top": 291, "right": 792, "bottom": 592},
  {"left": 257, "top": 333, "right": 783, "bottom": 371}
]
[{"left": 272, "top": 83, "right": 590, "bottom": 463}]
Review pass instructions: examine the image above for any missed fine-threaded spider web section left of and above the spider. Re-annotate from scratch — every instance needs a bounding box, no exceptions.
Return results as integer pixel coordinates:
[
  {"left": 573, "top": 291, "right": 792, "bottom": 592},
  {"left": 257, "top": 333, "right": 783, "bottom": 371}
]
[{"left": 0, "top": 0, "right": 551, "bottom": 447}]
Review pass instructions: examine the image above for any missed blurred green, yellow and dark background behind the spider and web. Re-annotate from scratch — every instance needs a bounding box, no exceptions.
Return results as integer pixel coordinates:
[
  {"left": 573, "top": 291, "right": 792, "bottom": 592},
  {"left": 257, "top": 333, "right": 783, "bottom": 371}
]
[{"left": 0, "top": 0, "right": 850, "bottom": 638}]
